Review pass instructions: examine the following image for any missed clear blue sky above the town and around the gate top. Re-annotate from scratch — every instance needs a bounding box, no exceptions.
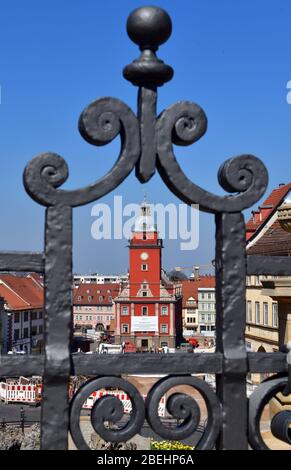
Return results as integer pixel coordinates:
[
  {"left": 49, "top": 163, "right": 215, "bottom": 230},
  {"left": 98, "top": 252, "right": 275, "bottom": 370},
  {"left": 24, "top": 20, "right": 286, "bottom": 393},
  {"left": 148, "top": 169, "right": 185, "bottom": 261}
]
[{"left": 0, "top": 0, "right": 291, "bottom": 272}]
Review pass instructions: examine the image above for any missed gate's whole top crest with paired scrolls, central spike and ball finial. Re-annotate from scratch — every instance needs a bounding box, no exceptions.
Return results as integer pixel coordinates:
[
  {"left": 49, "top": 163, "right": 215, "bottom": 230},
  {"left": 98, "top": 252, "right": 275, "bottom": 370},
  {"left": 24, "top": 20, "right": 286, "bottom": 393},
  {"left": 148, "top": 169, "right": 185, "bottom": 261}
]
[{"left": 24, "top": 7, "right": 268, "bottom": 213}]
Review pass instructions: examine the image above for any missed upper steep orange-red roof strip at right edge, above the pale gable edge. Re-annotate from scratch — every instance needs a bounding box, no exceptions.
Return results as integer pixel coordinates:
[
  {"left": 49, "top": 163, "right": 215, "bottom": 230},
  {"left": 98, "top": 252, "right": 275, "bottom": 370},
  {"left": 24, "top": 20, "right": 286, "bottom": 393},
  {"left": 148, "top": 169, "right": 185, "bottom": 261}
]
[{"left": 246, "top": 183, "right": 291, "bottom": 240}]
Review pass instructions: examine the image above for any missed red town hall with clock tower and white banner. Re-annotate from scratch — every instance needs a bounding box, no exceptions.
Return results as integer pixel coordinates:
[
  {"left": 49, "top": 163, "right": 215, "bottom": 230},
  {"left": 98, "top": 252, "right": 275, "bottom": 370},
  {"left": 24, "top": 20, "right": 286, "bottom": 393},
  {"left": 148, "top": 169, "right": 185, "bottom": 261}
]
[{"left": 114, "top": 202, "right": 182, "bottom": 351}]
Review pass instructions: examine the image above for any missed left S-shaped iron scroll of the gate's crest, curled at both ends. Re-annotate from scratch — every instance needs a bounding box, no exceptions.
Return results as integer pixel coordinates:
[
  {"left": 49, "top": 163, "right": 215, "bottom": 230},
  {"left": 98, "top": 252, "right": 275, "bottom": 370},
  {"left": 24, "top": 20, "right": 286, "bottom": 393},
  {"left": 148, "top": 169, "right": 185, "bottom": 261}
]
[{"left": 24, "top": 98, "right": 140, "bottom": 207}]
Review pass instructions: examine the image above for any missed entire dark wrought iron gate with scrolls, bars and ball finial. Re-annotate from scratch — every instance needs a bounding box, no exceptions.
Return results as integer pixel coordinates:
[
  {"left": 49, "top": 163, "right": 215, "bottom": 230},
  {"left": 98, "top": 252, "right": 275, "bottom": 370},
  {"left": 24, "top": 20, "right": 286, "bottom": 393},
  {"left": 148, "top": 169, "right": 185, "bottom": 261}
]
[{"left": 0, "top": 7, "right": 291, "bottom": 449}]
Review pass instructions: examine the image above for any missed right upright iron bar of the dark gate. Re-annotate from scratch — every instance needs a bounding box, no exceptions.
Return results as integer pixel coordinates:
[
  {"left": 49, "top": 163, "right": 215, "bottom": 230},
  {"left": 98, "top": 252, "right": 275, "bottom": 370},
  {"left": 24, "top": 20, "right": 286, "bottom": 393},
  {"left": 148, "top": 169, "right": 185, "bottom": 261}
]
[{"left": 215, "top": 213, "right": 248, "bottom": 450}]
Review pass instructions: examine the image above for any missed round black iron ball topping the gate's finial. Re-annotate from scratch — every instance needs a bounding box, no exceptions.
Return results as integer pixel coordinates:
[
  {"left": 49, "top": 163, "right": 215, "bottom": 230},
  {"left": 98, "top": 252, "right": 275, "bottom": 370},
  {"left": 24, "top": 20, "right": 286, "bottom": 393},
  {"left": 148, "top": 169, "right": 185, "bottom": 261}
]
[{"left": 127, "top": 6, "right": 172, "bottom": 49}]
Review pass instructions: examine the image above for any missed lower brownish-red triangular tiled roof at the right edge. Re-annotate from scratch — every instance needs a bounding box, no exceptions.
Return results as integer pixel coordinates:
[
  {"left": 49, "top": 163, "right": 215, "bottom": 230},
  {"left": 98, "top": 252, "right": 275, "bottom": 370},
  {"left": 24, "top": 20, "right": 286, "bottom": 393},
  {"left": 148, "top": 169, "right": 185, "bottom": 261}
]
[{"left": 247, "top": 220, "right": 291, "bottom": 256}]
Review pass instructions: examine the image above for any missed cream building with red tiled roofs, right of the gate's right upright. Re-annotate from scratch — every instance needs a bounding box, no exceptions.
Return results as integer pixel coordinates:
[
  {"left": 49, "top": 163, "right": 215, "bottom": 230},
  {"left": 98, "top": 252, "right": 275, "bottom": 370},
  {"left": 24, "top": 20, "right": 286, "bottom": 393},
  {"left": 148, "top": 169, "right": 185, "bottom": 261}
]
[{"left": 245, "top": 183, "right": 291, "bottom": 352}]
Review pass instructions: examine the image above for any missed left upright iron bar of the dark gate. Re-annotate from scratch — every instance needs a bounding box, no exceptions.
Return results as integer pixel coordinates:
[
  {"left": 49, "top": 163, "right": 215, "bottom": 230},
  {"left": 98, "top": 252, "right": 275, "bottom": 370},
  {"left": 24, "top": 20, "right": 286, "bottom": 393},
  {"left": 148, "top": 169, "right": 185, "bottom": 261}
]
[{"left": 41, "top": 205, "right": 72, "bottom": 450}]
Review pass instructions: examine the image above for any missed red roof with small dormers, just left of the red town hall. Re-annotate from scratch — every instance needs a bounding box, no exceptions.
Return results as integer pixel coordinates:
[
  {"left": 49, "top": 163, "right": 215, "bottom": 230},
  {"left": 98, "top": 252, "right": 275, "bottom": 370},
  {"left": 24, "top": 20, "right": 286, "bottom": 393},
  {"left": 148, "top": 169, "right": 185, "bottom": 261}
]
[{"left": 73, "top": 283, "right": 120, "bottom": 305}]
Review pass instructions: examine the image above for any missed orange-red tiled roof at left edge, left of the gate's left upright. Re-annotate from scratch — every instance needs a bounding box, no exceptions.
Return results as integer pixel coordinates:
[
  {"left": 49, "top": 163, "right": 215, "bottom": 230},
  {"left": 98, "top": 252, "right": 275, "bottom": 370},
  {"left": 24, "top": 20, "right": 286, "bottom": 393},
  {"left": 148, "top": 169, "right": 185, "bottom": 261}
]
[{"left": 0, "top": 274, "right": 44, "bottom": 310}]
